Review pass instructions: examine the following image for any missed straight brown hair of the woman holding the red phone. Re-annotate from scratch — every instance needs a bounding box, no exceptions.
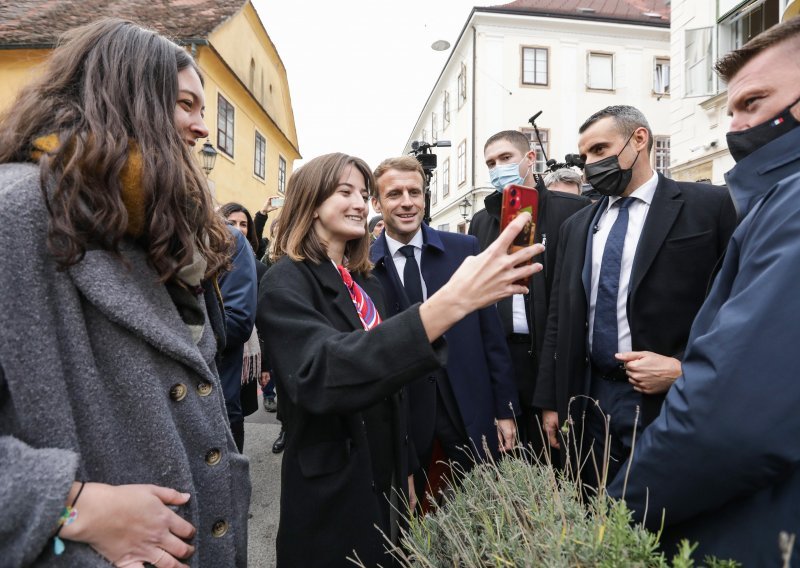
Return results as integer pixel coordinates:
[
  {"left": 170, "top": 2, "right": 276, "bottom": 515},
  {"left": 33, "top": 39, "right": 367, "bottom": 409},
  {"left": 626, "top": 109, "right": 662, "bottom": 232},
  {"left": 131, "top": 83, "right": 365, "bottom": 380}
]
[{"left": 272, "top": 153, "right": 375, "bottom": 275}]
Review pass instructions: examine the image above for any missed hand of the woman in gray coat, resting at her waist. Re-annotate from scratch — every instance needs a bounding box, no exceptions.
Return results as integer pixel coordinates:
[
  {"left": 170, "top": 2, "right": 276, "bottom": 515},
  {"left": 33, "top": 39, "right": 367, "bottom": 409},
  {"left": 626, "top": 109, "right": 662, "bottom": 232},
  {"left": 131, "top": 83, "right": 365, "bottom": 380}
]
[{"left": 60, "top": 483, "right": 195, "bottom": 568}]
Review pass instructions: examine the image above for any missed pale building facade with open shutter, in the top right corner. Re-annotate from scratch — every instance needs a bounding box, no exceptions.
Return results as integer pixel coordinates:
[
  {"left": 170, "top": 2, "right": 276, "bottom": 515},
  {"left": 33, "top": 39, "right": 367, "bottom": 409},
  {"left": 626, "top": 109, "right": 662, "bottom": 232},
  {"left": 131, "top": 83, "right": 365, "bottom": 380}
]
[{"left": 670, "top": 0, "right": 800, "bottom": 184}]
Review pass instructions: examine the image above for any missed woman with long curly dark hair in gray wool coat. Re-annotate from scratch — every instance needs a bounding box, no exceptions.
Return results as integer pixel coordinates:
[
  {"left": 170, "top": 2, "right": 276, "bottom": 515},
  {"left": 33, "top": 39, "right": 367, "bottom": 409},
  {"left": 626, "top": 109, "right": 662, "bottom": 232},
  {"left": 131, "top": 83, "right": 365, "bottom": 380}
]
[{"left": 0, "top": 20, "right": 250, "bottom": 568}]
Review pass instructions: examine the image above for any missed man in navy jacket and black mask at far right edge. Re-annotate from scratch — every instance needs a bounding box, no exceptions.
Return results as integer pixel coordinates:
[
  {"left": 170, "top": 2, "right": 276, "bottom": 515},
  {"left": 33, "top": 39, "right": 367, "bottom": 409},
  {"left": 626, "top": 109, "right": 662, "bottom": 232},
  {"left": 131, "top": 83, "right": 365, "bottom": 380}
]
[{"left": 609, "top": 17, "right": 800, "bottom": 566}]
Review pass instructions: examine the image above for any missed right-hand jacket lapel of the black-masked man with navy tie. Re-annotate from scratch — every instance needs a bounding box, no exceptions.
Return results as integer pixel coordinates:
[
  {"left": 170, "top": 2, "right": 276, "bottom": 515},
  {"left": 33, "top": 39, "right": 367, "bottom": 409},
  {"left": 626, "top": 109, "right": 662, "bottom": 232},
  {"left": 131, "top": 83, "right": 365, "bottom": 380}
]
[{"left": 629, "top": 178, "right": 683, "bottom": 297}]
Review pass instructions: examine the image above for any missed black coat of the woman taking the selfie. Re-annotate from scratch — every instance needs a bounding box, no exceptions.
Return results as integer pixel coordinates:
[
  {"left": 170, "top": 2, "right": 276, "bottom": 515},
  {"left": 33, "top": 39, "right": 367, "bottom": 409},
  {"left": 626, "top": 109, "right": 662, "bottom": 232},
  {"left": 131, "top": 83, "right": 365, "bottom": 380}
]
[{"left": 258, "top": 257, "right": 445, "bottom": 567}]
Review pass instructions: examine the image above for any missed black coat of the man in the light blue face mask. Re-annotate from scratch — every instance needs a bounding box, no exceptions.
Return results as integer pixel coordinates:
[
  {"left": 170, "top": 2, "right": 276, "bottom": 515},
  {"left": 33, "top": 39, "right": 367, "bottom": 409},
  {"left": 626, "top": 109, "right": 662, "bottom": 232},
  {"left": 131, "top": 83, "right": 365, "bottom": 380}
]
[{"left": 469, "top": 187, "right": 591, "bottom": 405}]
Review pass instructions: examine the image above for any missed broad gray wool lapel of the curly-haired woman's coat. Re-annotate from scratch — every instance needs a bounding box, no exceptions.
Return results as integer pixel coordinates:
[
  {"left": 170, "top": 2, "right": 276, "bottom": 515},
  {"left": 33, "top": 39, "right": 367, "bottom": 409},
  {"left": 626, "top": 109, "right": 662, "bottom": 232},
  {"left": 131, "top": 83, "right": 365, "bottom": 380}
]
[{"left": 68, "top": 245, "right": 217, "bottom": 379}]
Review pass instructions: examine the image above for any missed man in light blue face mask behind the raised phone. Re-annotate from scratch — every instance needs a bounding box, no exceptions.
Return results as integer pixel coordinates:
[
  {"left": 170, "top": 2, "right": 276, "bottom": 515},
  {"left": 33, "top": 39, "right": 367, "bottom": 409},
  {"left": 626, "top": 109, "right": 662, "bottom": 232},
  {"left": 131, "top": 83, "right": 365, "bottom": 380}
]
[{"left": 469, "top": 130, "right": 590, "bottom": 454}]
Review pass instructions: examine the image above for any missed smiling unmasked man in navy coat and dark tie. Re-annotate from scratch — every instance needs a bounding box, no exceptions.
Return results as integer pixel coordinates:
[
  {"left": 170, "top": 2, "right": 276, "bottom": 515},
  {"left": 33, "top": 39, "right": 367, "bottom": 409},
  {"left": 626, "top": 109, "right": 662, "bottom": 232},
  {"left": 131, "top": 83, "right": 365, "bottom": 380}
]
[{"left": 370, "top": 156, "right": 519, "bottom": 491}]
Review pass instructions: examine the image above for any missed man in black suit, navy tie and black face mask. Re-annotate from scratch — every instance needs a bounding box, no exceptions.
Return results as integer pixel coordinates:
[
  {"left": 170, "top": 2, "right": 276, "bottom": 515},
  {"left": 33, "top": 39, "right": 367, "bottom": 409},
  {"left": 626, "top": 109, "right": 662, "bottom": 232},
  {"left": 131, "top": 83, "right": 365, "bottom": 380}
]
[{"left": 534, "top": 106, "right": 736, "bottom": 487}]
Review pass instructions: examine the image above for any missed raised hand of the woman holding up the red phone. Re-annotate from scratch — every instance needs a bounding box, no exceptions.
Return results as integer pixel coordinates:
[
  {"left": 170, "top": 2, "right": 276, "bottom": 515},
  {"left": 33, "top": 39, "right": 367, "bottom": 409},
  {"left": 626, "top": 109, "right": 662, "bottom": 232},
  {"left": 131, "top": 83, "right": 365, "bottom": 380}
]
[{"left": 419, "top": 213, "right": 544, "bottom": 341}]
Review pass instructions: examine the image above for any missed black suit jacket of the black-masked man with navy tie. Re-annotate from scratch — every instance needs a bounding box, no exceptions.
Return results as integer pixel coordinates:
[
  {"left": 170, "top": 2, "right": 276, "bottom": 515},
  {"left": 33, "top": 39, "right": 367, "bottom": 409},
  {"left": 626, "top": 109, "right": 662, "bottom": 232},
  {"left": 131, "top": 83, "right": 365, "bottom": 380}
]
[{"left": 534, "top": 174, "right": 736, "bottom": 440}]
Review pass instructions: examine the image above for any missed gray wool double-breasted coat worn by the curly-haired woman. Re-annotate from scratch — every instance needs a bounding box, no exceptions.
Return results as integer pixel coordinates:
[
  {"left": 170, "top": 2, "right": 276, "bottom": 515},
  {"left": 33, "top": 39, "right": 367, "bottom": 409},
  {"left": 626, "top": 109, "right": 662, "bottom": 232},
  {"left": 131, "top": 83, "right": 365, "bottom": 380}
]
[{"left": 0, "top": 164, "right": 250, "bottom": 567}]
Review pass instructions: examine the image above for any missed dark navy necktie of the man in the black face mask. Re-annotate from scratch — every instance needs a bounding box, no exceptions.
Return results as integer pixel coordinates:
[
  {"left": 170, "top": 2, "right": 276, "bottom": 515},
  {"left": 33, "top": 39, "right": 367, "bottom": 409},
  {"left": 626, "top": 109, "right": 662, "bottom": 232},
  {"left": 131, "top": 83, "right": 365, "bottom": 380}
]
[{"left": 592, "top": 197, "right": 636, "bottom": 371}]
